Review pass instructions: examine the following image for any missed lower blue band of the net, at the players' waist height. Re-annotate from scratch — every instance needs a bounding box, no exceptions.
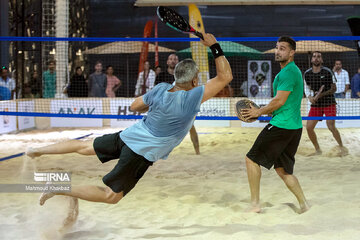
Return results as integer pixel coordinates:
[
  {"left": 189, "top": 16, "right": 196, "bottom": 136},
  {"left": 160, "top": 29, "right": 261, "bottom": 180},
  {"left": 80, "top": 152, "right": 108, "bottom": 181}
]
[{"left": 0, "top": 111, "right": 360, "bottom": 121}]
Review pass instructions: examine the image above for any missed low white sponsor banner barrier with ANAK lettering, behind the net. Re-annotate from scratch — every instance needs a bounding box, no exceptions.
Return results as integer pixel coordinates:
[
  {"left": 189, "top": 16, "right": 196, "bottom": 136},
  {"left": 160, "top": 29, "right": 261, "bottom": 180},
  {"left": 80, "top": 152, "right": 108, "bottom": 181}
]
[{"left": 0, "top": 98, "right": 360, "bottom": 134}]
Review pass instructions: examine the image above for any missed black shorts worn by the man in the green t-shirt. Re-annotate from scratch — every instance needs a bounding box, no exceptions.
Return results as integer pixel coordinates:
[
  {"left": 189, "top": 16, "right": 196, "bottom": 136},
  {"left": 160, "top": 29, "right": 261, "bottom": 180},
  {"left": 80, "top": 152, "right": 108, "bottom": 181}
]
[{"left": 246, "top": 124, "right": 302, "bottom": 174}]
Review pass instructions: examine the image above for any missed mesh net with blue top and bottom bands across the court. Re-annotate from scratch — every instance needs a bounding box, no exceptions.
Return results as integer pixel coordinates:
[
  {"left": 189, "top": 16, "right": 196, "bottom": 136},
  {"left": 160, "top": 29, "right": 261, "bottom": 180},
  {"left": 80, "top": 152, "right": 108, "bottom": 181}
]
[{"left": 0, "top": 36, "right": 360, "bottom": 126}]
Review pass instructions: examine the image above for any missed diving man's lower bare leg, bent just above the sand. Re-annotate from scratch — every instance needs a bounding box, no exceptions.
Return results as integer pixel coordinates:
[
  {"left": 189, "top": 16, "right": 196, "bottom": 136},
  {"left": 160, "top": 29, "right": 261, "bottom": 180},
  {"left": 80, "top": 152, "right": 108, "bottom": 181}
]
[{"left": 40, "top": 185, "right": 124, "bottom": 205}]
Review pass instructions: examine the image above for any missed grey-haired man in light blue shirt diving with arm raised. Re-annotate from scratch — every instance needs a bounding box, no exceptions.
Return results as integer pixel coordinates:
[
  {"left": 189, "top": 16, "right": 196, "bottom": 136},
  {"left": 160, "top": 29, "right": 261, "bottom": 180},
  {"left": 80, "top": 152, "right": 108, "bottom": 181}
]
[{"left": 27, "top": 33, "right": 232, "bottom": 205}]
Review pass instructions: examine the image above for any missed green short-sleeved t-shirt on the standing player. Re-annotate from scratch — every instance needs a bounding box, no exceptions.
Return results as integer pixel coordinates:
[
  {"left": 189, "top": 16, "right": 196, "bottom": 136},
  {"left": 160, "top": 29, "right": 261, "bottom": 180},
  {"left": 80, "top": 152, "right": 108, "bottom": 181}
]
[{"left": 270, "top": 62, "right": 304, "bottom": 129}]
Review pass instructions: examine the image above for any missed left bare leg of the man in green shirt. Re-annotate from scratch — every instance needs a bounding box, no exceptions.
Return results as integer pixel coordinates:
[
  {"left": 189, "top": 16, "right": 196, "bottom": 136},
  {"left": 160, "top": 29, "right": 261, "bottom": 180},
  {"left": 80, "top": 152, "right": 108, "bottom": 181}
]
[{"left": 245, "top": 157, "right": 261, "bottom": 213}]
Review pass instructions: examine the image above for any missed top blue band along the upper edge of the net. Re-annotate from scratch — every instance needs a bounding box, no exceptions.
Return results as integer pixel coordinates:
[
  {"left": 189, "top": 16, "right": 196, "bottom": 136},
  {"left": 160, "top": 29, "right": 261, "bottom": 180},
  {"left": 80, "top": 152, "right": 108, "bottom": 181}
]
[{"left": 0, "top": 36, "right": 360, "bottom": 42}]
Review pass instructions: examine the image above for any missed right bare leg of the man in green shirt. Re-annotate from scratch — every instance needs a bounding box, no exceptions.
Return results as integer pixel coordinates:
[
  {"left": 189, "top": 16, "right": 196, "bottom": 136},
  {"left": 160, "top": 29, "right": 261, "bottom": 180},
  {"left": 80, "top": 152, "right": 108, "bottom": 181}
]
[{"left": 275, "top": 168, "right": 310, "bottom": 213}]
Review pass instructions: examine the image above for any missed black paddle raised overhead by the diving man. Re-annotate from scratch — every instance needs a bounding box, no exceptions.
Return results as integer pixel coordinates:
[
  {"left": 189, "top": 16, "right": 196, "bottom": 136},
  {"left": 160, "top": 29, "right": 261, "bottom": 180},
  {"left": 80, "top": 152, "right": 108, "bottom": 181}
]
[{"left": 157, "top": 6, "right": 204, "bottom": 40}]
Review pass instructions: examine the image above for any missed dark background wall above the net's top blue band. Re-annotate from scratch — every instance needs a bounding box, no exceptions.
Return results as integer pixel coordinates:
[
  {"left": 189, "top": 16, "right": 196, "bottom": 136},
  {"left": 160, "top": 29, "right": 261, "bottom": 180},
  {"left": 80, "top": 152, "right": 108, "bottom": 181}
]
[{"left": 90, "top": 0, "right": 360, "bottom": 37}]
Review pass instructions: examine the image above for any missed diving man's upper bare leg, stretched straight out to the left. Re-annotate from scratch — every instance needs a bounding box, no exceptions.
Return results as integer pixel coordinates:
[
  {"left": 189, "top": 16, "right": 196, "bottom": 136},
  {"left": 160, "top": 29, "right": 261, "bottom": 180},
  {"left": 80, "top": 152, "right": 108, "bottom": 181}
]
[{"left": 26, "top": 140, "right": 95, "bottom": 158}]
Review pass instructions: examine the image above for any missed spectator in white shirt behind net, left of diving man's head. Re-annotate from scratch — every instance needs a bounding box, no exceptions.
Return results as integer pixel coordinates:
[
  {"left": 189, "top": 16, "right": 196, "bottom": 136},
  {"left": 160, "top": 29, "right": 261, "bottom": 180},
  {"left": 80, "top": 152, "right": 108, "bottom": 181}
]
[{"left": 135, "top": 61, "right": 156, "bottom": 97}]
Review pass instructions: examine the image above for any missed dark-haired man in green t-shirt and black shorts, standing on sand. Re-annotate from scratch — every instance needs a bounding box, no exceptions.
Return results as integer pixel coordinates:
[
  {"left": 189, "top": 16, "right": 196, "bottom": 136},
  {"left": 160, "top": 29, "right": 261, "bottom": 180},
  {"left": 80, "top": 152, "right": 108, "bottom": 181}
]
[{"left": 242, "top": 36, "right": 309, "bottom": 213}]
